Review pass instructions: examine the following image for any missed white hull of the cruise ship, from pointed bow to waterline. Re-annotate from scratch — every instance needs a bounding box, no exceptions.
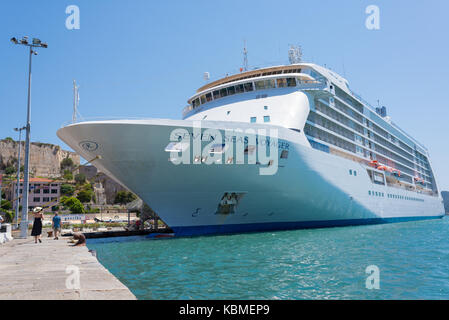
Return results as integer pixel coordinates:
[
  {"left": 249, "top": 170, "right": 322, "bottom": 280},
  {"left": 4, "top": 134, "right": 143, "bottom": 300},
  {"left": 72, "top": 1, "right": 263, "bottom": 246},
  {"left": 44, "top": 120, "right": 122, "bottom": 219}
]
[{"left": 58, "top": 120, "right": 444, "bottom": 236}]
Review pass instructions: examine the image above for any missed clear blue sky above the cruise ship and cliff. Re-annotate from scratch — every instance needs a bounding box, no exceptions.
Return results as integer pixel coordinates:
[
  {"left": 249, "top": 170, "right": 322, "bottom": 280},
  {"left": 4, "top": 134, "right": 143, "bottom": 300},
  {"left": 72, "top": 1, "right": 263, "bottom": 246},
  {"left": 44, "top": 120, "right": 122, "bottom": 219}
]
[{"left": 0, "top": 0, "right": 449, "bottom": 190}]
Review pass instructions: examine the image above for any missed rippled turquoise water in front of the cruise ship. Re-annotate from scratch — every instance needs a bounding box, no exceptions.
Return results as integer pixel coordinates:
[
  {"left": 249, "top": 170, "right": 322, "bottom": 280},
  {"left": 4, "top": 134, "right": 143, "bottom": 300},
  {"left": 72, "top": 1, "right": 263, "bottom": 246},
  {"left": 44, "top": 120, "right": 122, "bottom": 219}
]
[{"left": 86, "top": 218, "right": 449, "bottom": 299}]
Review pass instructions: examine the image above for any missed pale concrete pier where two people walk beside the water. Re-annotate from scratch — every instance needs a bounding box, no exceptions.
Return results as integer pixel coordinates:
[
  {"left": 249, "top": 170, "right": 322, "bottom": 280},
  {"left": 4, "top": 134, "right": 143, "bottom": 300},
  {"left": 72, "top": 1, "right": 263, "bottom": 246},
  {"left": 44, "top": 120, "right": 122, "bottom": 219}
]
[{"left": 0, "top": 237, "right": 136, "bottom": 300}]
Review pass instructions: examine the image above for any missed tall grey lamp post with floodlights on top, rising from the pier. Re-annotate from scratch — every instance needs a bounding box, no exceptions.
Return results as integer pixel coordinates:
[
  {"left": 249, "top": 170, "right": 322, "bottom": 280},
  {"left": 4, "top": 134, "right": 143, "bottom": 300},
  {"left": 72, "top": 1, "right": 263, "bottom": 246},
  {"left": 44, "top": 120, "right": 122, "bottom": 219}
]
[{"left": 11, "top": 37, "right": 48, "bottom": 239}]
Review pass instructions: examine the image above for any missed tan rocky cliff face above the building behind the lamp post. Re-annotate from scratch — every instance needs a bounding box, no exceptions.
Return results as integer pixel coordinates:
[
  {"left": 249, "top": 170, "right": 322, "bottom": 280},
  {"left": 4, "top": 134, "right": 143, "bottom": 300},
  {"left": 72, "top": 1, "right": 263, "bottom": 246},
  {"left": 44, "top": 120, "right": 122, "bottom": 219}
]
[{"left": 0, "top": 139, "right": 80, "bottom": 178}]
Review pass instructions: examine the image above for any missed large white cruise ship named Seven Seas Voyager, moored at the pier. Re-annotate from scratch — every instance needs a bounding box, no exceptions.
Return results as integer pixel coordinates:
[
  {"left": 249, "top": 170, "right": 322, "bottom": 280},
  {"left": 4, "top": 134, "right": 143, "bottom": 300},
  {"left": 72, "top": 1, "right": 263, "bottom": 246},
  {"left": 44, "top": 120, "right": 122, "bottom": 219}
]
[{"left": 57, "top": 58, "right": 444, "bottom": 236}]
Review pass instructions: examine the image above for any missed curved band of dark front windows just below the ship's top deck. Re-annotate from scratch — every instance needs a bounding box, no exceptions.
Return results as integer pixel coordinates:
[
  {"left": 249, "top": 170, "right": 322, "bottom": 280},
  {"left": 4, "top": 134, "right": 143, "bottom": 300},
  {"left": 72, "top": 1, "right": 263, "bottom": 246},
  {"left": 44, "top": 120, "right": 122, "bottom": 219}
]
[{"left": 192, "top": 77, "right": 301, "bottom": 108}]
